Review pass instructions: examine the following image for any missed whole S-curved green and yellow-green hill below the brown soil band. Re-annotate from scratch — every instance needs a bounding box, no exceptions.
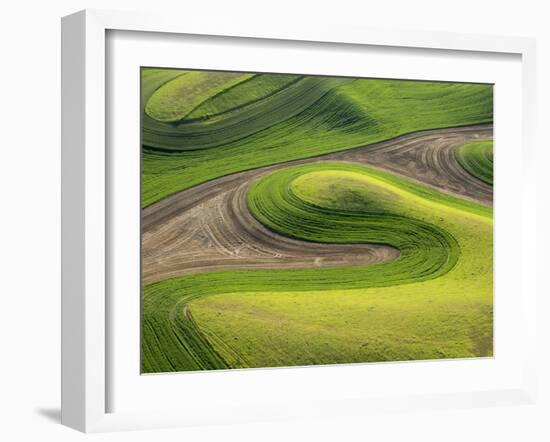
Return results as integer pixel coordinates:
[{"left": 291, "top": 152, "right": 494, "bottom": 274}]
[{"left": 142, "top": 163, "right": 493, "bottom": 373}]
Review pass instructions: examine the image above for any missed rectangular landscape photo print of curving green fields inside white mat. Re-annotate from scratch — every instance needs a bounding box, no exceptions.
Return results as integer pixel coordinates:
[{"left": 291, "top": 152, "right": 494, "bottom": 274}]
[{"left": 140, "top": 67, "right": 493, "bottom": 374}]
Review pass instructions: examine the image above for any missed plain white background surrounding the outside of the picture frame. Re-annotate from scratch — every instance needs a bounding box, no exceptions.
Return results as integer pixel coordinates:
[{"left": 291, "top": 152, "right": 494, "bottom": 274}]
[{"left": 0, "top": 0, "right": 550, "bottom": 441}]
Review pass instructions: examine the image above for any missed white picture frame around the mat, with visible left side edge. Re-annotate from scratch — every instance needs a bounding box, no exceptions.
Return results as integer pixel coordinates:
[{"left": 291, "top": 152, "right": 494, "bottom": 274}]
[{"left": 62, "top": 10, "right": 537, "bottom": 432}]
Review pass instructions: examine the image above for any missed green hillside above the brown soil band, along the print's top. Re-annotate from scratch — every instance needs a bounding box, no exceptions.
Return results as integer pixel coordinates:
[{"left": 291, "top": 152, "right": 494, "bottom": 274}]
[{"left": 142, "top": 69, "right": 493, "bottom": 206}]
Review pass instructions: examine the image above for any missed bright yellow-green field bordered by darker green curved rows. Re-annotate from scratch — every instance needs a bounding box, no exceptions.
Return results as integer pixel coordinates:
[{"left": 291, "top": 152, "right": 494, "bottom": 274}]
[{"left": 189, "top": 170, "right": 493, "bottom": 367}]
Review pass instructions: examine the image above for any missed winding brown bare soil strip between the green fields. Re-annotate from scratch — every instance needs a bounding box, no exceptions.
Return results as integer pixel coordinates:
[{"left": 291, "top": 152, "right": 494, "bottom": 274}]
[{"left": 142, "top": 125, "right": 493, "bottom": 284}]
